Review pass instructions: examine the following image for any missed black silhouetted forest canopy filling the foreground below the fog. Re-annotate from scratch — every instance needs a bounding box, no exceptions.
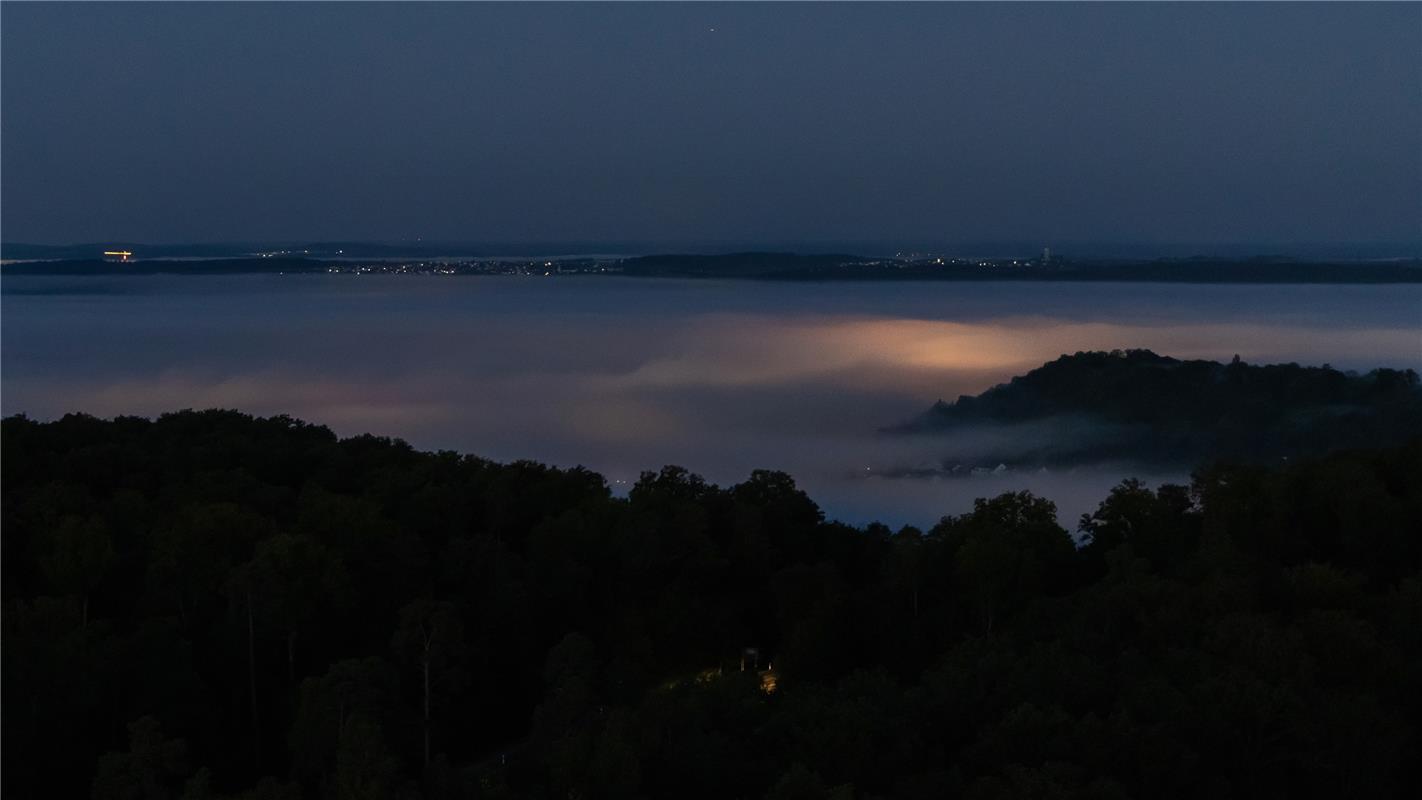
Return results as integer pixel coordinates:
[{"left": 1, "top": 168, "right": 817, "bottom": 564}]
[{"left": 0, "top": 411, "right": 1422, "bottom": 800}]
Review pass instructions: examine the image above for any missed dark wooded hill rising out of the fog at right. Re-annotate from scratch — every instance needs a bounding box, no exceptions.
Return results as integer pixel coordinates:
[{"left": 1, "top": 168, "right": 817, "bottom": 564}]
[{"left": 889, "top": 350, "right": 1422, "bottom": 475}]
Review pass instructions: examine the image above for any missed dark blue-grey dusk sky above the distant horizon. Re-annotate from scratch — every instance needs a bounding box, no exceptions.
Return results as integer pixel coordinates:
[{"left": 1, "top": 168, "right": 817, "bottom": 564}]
[{"left": 0, "top": 3, "right": 1422, "bottom": 243}]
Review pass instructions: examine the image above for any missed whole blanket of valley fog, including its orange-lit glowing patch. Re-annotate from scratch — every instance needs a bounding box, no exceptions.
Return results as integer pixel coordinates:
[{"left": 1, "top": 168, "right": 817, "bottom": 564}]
[{"left": 0, "top": 276, "right": 1422, "bottom": 526}]
